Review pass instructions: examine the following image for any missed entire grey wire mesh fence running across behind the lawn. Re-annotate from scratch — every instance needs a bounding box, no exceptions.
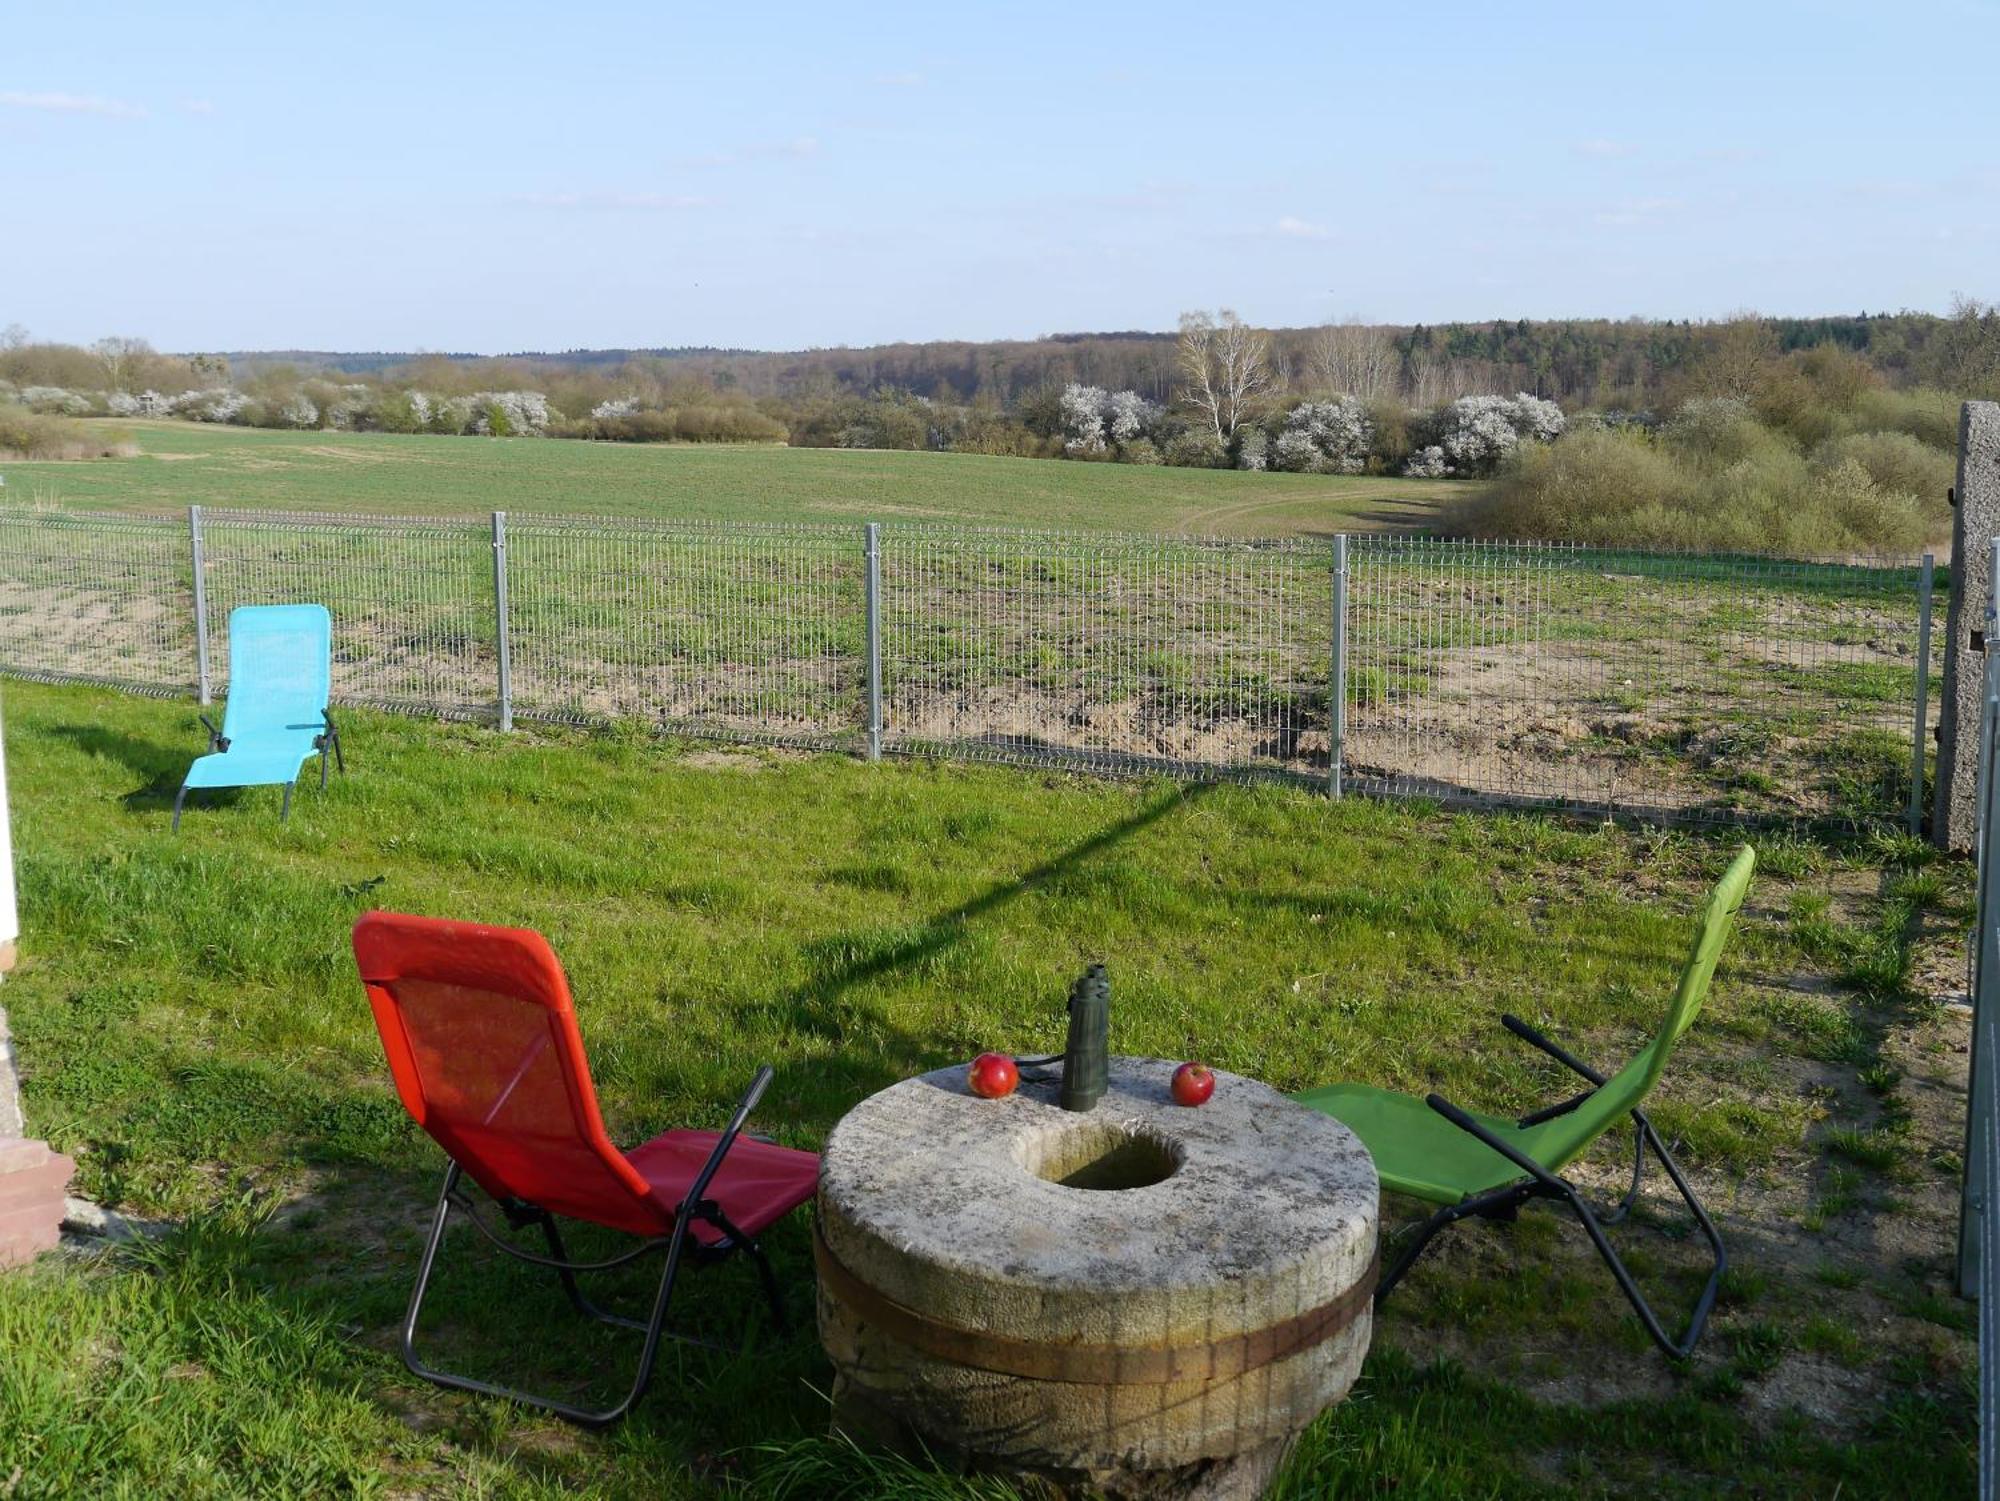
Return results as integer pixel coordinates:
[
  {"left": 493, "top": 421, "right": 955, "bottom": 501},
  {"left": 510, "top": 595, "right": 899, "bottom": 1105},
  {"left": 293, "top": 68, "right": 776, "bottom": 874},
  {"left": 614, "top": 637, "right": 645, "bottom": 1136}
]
[{"left": 0, "top": 510, "right": 1930, "bottom": 836}]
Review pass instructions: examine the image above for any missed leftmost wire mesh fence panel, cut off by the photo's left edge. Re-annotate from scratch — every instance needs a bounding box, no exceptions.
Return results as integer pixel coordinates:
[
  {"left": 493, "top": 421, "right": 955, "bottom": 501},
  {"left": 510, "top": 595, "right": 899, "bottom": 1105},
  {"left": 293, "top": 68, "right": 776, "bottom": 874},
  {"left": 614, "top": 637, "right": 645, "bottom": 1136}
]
[{"left": 0, "top": 510, "right": 194, "bottom": 692}]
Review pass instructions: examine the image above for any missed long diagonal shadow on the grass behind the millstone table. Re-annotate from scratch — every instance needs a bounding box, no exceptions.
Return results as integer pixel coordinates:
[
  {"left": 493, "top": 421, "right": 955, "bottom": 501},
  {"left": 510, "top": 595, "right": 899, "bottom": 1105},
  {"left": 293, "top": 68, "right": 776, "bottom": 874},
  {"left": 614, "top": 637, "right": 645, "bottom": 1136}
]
[{"left": 780, "top": 783, "right": 1216, "bottom": 1099}]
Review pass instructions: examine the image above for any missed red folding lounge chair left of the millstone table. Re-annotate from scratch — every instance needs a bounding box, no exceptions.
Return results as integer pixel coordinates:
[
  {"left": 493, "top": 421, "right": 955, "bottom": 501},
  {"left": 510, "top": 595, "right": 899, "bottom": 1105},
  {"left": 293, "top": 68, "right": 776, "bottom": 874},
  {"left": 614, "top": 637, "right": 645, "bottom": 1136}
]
[{"left": 354, "top": 913, "right": 820, "bottom": 1427}]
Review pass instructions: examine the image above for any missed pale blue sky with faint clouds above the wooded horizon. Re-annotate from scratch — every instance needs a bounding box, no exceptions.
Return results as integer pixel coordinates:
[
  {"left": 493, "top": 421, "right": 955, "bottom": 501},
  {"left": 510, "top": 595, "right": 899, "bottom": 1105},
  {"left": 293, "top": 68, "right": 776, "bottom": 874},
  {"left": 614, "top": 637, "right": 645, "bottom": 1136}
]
[{"left": 0, "top": 0, "right": 2000, "bottom": 352}]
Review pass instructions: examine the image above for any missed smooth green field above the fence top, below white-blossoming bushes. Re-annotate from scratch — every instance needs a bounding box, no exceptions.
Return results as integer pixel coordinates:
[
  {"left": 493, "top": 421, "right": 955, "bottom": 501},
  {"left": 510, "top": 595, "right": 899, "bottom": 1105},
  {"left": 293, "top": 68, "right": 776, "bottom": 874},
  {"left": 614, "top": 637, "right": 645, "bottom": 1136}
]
[{"left": 0, "top": 420, "right": 1468, "bottom": 536}]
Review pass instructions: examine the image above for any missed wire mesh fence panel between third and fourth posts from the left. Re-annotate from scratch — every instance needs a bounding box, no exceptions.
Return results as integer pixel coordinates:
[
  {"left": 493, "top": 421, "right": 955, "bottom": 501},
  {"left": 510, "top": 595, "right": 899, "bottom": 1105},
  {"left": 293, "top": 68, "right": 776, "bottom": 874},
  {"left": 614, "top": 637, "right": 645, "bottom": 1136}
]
[{"left": 882, "top": 524, "right": 1332, "bottom": 779}]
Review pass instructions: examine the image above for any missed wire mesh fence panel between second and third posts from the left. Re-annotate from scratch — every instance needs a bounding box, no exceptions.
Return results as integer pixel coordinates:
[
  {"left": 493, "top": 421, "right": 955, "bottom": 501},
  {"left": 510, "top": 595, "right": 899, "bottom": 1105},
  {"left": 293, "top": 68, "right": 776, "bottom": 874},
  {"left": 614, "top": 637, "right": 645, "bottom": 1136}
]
[{"left": 506, "top": 512, "right": 864, "bottom": 746}]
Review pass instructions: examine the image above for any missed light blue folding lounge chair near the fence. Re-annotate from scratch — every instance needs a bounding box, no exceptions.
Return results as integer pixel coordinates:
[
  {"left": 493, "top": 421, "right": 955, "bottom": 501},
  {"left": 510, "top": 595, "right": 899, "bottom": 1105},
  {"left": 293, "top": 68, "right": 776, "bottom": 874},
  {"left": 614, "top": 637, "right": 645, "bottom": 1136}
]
[{"left": 174, "top": 604, "right": 348, "bottom": 833}]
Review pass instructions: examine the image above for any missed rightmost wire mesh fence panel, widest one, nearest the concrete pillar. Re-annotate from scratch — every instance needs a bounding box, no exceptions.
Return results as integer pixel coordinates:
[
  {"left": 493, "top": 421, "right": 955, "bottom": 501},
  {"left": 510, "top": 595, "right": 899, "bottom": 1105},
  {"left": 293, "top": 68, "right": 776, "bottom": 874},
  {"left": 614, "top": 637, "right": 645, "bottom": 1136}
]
[{"left": 1348, "top": 536, "right": 1920, "bottom": 823}]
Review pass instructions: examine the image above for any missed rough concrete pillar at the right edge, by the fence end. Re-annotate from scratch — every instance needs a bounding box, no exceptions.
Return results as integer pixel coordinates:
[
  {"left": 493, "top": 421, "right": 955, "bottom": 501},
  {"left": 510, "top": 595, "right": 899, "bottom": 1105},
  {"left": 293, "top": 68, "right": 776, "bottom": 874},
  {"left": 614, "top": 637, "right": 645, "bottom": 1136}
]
[{"left": 1930, "top": 402, "right": 2000, "bottom": 851}]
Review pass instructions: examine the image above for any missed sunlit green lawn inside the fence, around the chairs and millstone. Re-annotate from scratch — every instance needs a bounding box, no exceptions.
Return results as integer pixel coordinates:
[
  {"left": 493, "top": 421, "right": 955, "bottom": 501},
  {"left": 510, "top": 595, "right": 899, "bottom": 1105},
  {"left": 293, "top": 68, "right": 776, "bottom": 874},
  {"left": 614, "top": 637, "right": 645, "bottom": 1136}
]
[{"left": 0, "top": 684, "right": 1974, "bottom": 1499}]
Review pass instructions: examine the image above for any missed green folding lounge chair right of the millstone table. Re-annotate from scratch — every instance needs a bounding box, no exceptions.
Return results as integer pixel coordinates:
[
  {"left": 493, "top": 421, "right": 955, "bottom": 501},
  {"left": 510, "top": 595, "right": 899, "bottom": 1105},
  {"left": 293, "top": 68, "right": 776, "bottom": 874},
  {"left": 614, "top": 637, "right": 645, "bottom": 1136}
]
[{"left": 1294, "top": 845, "right": 1756, "bottom": 1359}]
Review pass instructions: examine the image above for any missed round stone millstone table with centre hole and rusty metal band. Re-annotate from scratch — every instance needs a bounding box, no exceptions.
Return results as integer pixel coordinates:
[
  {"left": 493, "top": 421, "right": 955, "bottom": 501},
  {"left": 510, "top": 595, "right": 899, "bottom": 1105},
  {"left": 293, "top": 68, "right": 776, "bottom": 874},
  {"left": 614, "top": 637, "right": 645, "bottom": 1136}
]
[{"left": 816, "top": 1059, "right": 1378, "bottom": 1497}]
